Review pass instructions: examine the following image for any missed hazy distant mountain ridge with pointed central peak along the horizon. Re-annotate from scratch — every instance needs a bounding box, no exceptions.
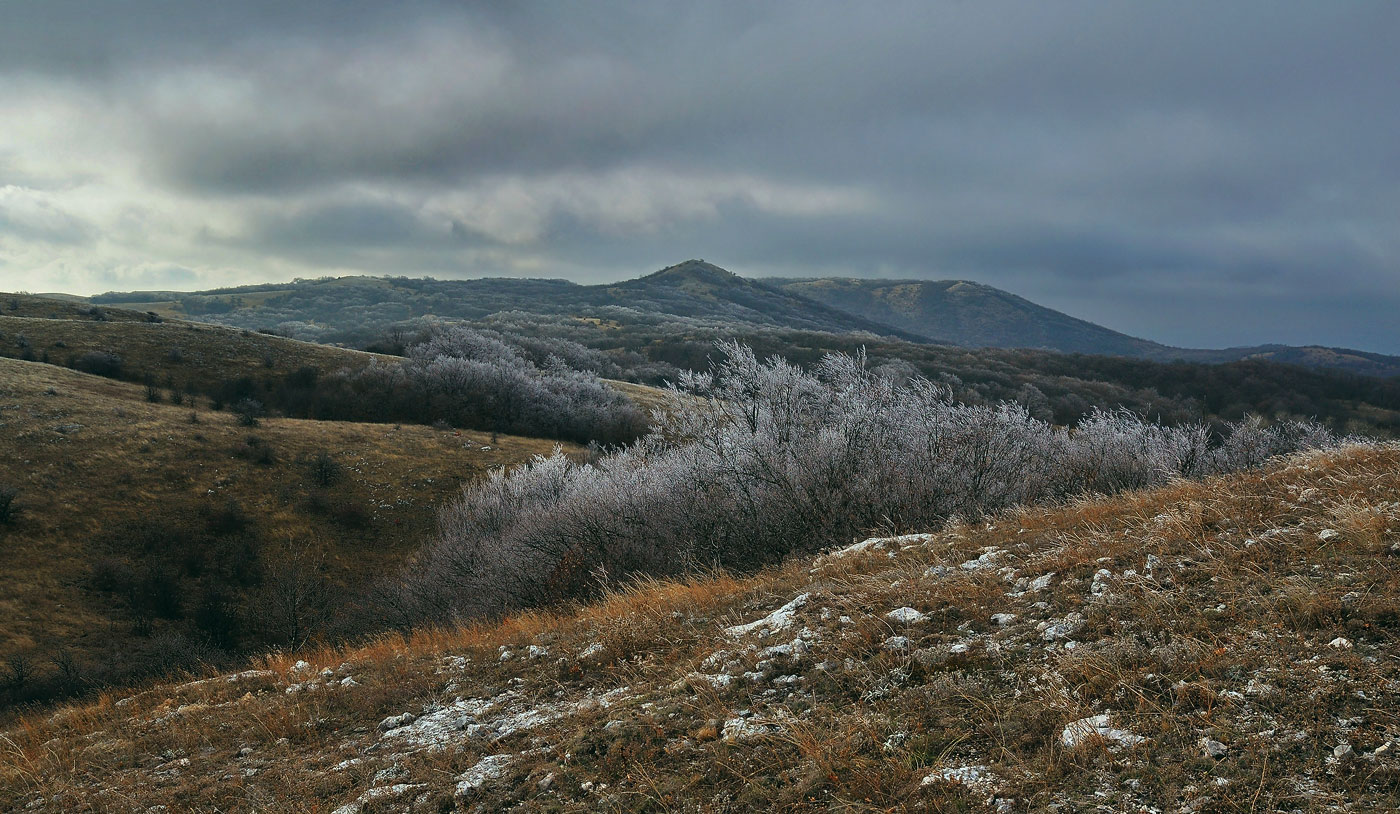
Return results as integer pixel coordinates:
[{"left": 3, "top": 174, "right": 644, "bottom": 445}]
[{"left": 91, "top": 259, "right": 1400, "bottom": 377}]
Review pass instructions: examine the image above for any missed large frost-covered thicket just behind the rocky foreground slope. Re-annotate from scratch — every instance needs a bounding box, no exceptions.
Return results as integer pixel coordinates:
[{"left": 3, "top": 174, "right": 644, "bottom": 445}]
[{"left": 384, "top": 343, "right": 1336, "bottom": 625}]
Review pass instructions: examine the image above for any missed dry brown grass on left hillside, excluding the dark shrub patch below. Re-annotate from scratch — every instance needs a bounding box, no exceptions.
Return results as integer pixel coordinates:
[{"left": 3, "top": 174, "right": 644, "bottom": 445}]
[{"left": 0, "top": 359, "right": 574, "bottom": 700}]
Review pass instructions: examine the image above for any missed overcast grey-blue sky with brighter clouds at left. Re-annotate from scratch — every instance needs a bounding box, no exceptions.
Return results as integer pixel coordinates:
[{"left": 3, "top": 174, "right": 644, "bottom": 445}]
[{"left": 0, "top": 0, "right": 1400, "bottom": 353}]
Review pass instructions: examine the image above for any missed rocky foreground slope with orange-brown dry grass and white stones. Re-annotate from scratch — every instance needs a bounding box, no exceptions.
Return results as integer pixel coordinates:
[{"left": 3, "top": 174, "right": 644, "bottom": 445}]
[{"left": 0, "top": 444, "right": 1400, "bottom": 814}]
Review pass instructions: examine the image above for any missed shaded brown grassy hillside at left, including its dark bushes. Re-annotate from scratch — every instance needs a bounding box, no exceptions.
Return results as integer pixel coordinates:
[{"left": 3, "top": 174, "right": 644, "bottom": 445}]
[{"left": 0, "top": 358, "right": 574, "bottom": 699}]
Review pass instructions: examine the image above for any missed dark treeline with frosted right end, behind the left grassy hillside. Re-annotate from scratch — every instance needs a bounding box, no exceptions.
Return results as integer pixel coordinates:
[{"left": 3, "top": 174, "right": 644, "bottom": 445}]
[{"left": 0, "top": 325, "right": 647, "bottom": 444}]
